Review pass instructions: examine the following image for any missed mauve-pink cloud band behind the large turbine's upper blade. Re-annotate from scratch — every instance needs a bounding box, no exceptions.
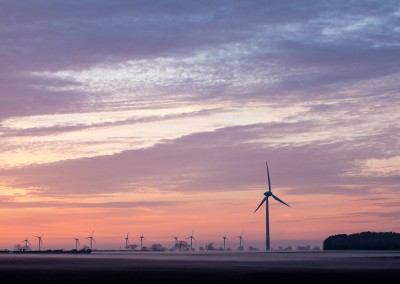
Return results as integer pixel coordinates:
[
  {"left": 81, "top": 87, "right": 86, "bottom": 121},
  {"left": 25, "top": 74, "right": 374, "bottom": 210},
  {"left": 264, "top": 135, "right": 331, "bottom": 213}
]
[{"left": 3, "top": 119, "right": 396, "bottom": 196}]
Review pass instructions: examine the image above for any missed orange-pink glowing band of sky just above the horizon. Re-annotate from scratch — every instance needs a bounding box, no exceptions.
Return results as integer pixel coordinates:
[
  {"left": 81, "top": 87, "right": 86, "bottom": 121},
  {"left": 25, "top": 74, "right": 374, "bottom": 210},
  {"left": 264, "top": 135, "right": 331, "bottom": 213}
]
[{"left": 0, "top": 186, "right": 398, "bottom": 249}]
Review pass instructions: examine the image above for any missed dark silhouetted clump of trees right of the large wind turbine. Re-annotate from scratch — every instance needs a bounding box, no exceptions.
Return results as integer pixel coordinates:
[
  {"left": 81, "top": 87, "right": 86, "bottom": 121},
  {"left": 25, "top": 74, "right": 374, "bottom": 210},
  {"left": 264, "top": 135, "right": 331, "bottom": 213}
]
[{"left": 324, "top": 232, "right": 400, "bottom": 250}]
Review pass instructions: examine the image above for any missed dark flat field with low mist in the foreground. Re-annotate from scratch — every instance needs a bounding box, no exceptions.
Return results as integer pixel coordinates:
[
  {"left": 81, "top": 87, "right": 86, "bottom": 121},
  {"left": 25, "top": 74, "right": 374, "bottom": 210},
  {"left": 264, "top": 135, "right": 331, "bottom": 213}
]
[{"left": 0, "top": 252, "right": 400, "bottom": 284}]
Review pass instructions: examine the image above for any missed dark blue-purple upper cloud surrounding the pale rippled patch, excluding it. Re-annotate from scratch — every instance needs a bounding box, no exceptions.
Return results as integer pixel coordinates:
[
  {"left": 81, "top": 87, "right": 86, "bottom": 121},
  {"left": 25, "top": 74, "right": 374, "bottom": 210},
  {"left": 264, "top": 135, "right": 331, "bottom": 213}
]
[{"left": 0, "top": 1, "right": 400, "bottom": 119}]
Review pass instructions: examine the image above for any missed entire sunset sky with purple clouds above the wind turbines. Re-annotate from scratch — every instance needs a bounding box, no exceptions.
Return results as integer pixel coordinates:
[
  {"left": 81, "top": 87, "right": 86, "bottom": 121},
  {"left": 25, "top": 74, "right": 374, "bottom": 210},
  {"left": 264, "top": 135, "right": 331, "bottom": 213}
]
[{"left": 0, "top": 0, "right": 400, "bottom": 249}]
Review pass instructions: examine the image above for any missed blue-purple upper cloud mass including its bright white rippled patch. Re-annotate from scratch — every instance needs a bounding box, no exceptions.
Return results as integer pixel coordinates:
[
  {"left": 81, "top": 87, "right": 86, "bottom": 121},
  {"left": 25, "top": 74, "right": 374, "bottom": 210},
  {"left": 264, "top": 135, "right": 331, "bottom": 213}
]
[{"left": 0, "top": 1, "right": 400, "bottom": 123}]
